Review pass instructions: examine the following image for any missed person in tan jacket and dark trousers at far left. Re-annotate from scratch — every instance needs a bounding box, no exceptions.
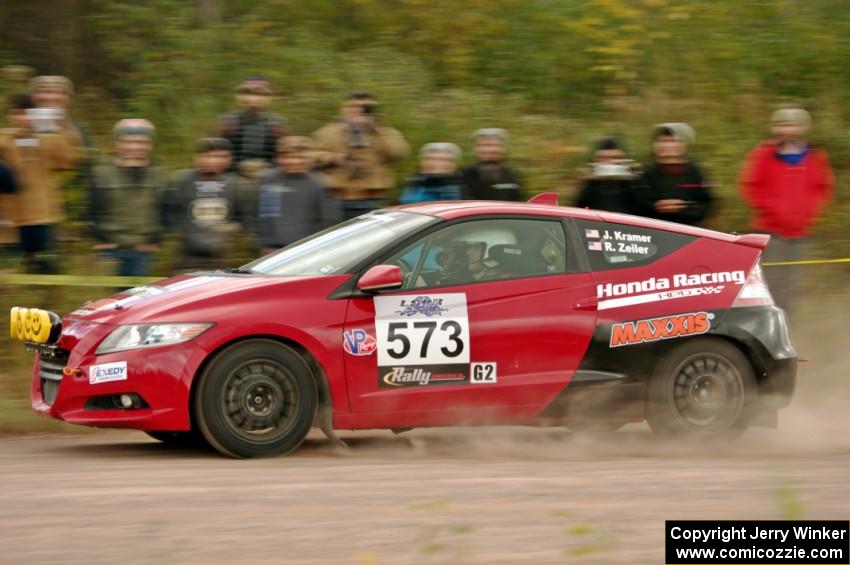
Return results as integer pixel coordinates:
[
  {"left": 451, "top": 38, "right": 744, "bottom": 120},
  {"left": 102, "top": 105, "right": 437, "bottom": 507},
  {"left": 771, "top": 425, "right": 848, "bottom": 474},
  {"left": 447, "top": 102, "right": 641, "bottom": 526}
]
[{"left": 0, "top": 94, "right": 80, "bottom": 274}]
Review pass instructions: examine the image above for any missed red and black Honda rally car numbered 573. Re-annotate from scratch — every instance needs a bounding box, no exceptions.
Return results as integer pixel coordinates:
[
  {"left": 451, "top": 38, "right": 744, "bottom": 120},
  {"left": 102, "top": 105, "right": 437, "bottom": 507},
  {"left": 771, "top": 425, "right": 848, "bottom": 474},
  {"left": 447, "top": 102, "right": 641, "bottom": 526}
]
[{"left": 11, "top": 197, "right": 797, "bottom": 457}]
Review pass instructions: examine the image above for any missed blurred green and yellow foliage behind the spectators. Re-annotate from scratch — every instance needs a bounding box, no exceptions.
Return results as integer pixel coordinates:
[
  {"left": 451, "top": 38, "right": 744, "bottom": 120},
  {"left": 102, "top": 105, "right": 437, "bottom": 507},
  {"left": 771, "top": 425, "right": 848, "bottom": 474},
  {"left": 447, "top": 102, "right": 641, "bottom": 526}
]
[{"left": 0, "top": 0, "right": 850, "bottom": 245}]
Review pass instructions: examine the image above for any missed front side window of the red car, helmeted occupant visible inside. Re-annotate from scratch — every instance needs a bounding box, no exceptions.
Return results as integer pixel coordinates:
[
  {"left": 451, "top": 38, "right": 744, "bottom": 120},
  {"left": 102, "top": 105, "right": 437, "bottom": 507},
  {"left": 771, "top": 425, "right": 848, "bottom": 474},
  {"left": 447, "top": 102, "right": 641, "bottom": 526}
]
[{"left": 385, "top": 219, "right": 567, "bottom": 289}]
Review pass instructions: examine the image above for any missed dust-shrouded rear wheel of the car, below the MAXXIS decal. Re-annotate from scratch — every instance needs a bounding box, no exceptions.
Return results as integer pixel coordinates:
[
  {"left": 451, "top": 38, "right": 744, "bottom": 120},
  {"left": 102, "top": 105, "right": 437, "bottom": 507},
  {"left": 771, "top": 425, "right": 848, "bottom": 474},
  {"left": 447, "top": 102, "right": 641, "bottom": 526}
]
[{"left": 646, "top": 338, "right": 755, "bottom": 437}]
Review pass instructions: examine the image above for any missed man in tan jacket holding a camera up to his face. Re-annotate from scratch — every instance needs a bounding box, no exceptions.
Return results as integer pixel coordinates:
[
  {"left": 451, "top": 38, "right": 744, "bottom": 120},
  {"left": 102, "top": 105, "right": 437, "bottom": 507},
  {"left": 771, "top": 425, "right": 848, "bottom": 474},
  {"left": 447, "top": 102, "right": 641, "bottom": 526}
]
[{"left": 313, "top": 92, "right": 410, "bottom": 220}]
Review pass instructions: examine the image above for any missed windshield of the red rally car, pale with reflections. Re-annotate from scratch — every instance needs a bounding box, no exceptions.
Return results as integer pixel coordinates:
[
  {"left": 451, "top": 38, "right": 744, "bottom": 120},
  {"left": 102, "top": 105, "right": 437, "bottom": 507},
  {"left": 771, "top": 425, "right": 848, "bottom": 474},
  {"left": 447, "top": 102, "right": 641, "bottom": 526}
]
[{"left": 240, "top": 211, "right": 438, "bottom": 276}]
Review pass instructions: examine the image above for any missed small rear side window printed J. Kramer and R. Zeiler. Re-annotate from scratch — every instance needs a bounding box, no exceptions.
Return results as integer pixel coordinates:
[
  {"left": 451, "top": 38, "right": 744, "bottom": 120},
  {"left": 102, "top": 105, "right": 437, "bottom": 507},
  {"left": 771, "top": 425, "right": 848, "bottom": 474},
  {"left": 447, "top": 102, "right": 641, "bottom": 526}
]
[{"left": 576, "top": 220, "right": 695, "bottom": 271}]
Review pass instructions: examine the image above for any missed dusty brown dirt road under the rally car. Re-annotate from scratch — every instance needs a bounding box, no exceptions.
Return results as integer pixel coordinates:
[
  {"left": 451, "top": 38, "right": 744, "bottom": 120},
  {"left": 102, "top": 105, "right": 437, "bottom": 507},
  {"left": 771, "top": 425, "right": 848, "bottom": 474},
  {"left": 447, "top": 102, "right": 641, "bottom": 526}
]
[{"left": 0, "top": 426, "right": 850, "bottom": 564}]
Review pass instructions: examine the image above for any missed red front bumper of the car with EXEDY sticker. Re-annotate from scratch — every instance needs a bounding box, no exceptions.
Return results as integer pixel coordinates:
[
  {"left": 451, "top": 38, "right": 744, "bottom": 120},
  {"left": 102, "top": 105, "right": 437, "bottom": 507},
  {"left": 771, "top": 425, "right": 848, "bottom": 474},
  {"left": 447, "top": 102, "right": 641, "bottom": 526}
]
[{"left": 31, "top": 324, "right": 206, "bottom": 431}]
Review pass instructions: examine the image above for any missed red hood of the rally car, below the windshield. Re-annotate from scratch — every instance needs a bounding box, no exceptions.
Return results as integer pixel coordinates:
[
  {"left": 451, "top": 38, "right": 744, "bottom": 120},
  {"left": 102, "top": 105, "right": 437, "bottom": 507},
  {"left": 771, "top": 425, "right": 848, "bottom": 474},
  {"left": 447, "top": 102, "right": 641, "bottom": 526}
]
[{"left": 65, "top": 273, "right": 351, "bottom": 324}]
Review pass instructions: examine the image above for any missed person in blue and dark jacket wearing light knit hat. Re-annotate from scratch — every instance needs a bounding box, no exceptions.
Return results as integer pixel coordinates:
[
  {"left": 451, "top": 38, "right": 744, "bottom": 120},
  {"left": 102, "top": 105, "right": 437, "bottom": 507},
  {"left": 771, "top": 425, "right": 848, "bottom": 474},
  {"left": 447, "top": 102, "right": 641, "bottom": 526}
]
[{"left": 399, "top": 143, "right": 471, "bottom": 204}]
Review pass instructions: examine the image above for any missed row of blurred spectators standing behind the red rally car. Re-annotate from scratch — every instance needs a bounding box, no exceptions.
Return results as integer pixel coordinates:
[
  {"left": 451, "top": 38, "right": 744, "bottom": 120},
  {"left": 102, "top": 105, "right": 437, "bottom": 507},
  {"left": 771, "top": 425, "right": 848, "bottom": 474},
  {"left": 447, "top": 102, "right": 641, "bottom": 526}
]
[{"left": 0, "top": 76, "right": 833, "bottom": 318}]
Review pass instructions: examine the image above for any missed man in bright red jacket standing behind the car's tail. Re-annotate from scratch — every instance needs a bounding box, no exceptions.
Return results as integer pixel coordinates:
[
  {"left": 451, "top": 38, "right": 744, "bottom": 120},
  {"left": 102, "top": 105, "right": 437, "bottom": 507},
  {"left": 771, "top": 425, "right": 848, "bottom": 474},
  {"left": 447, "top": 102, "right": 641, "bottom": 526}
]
[{"left": 740, "top": 108, "right": 834, "bottom": 314}]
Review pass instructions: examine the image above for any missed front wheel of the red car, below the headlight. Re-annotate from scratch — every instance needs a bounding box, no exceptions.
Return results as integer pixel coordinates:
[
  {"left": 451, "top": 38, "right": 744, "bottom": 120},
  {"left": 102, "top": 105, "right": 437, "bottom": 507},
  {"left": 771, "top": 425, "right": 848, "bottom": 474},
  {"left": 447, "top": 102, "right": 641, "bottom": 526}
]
[{"left": 195, "top": 339, "right": 318, "bottom": 457}]
